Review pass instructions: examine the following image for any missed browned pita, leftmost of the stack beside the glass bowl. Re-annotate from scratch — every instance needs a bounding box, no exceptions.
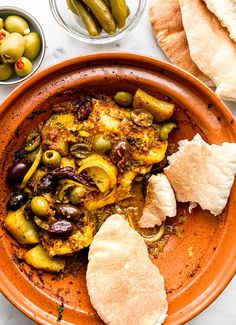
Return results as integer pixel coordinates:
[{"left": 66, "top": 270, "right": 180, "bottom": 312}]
[{"left": 150, "top": 0, "right": 214, "bottom": 86}]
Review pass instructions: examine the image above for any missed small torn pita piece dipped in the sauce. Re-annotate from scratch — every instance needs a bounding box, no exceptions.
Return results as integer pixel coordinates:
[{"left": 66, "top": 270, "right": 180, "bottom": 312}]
[{"left": 139, "top": 174, "right": 176, "bottom": 228}]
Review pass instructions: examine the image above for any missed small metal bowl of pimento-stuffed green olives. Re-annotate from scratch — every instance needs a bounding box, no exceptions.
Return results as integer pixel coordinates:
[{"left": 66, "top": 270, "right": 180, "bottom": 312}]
[{"left": 0, "top": 7, "right": 46, "bottom": 85}]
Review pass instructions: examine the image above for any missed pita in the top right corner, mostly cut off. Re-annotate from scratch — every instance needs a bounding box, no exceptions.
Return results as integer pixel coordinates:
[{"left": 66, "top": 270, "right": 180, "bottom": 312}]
[{"left": 203, "top": 0, "right": 236, "bottom": 41}]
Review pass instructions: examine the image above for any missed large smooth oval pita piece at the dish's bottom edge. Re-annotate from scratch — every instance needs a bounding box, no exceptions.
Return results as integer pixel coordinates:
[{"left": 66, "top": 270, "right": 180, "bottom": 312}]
[{"left": 86, "top": 214, "right": 168, "bottom": 325}]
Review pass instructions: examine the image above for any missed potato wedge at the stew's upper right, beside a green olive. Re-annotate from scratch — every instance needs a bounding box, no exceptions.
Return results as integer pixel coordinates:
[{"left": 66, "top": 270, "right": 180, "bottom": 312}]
[{"left": 133, "top": 89, "right": 175, "bottom": 122}]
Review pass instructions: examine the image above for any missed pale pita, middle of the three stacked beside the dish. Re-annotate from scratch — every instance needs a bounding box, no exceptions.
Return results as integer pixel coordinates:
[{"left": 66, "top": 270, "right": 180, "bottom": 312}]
[{"left": 179, "top": 0, "right": 236, "bottom": 101}]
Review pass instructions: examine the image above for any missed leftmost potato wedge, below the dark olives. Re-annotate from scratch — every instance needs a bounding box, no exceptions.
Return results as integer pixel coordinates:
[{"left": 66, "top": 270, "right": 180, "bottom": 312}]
[{"left": 5, "top": 206, "right": 39, "bottom": 245}]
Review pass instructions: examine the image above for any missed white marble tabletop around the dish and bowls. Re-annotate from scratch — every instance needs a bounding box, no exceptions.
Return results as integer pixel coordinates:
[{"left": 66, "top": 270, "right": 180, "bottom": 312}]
[{"left": 0, "top": 0, "right": 236, "bottom": 325}]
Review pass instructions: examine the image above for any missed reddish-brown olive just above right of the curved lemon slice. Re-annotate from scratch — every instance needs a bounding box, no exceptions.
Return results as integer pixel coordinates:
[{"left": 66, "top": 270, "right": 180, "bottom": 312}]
[{"left": 110, "top": 140, "right": 131, "bottom": 169}]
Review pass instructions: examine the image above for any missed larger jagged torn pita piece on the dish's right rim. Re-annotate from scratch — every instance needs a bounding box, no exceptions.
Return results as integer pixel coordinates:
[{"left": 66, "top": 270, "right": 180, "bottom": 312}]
[{"left": 164, "top": 134, "right": 236, "bottom": 216}]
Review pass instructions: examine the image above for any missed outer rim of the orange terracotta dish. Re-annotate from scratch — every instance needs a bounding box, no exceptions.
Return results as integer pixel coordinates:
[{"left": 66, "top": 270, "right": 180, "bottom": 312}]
[{"left": 0, "top": 52, "right": 236, "bottom": 325}]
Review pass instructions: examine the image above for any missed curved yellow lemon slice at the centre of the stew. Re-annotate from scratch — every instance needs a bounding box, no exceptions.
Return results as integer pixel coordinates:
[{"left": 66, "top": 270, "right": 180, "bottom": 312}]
[{"left": 78, "top": 154, "right": 117, "bottom": 193}]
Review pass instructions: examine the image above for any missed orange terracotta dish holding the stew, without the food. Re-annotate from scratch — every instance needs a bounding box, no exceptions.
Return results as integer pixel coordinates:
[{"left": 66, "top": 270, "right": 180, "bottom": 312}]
[{"left": 0, "top": 53, "right": 236, "bottom": 325}]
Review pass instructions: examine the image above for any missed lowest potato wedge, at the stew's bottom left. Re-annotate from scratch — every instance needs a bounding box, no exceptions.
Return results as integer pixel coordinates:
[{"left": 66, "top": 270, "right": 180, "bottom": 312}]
[{"left": 24, "top": 245, "right": 66, "bottom": 272}]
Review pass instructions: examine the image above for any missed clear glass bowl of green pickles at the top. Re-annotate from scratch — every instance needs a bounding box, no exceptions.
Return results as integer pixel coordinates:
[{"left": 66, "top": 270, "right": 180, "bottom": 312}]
[{"left": 49, "top": 0, "right": 146, "bottom": 44}]
